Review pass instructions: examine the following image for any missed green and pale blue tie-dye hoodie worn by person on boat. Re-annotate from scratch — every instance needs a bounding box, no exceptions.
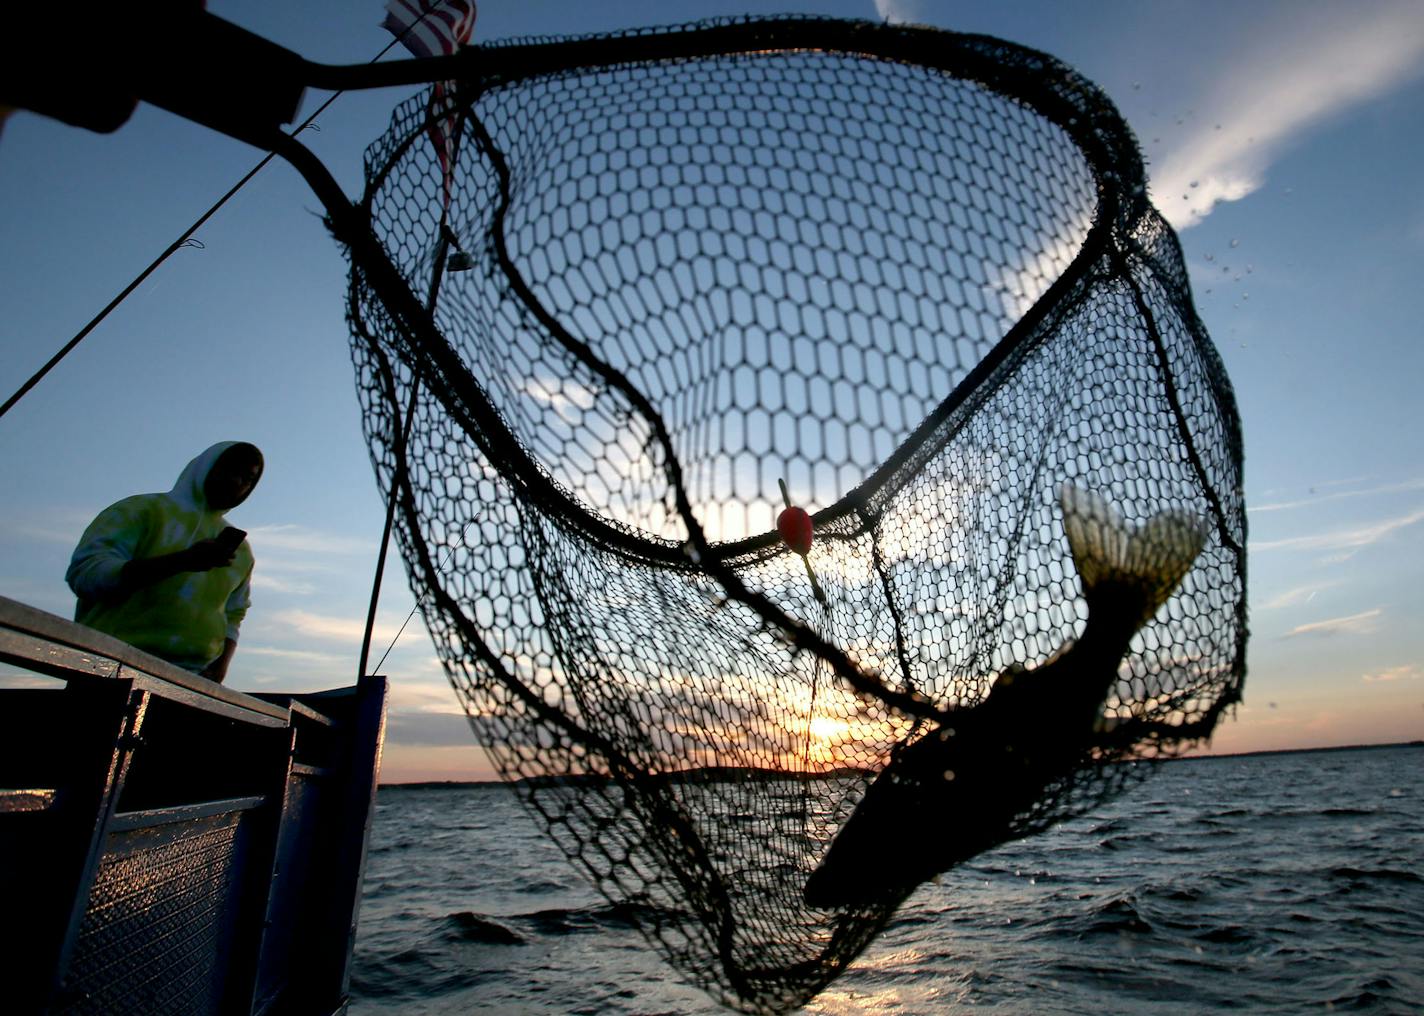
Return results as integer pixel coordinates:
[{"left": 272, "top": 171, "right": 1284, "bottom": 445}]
[{"left": 64, "top": 440, "right": 252, "bottom": 671}]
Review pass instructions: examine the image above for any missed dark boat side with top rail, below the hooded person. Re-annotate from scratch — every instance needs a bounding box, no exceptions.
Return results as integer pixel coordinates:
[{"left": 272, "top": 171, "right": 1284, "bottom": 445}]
[{"left": 0, "top": 597, "right": 386, "bottom": 1016}]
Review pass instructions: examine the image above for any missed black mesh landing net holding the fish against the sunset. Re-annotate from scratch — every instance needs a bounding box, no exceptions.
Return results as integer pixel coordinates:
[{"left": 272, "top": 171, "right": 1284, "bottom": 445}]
[{"left": 333, "top": 19, "right": 1246, "bottom": 1012}]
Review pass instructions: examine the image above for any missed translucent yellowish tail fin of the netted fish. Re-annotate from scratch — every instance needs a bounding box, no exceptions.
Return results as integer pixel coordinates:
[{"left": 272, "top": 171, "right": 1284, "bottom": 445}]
[{"left": 1058, "top": 483, "right": 1206, "bottom": 623}]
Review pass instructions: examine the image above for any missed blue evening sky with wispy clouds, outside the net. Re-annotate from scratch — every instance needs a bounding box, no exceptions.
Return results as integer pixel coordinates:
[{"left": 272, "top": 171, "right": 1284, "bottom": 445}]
[{"left": 0, "top": 0, "right": 1424, "bottom": 782}]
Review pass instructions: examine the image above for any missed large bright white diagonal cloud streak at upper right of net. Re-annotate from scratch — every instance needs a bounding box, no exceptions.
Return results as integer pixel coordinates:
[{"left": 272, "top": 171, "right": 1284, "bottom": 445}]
[{"left": 1150, "top": 3, "right": 1424, "bottom": 229}]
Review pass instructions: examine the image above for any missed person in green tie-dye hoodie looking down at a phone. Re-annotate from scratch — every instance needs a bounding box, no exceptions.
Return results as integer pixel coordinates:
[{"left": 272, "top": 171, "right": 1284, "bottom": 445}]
[{"left": 64, "top": 440, "right": 262, "bottom": 681}]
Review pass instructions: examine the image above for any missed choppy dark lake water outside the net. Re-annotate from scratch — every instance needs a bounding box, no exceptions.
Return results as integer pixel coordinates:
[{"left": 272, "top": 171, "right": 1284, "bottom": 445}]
[{"left": 352, "top": 745, "right": 1424, "bottom": 1016}]
